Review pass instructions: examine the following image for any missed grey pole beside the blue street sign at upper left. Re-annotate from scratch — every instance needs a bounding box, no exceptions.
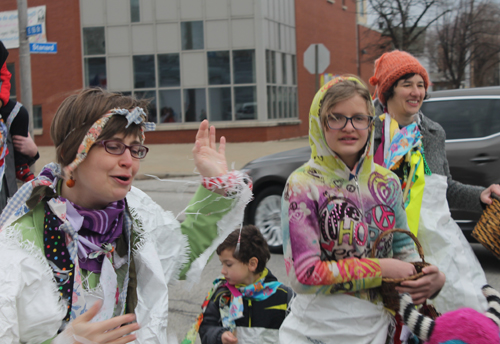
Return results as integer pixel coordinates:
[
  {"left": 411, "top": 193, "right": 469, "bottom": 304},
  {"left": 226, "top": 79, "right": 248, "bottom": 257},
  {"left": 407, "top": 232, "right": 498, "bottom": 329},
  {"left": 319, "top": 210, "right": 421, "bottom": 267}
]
[{"left": 17, "top": 0, "right": 35, "bottom": 140}]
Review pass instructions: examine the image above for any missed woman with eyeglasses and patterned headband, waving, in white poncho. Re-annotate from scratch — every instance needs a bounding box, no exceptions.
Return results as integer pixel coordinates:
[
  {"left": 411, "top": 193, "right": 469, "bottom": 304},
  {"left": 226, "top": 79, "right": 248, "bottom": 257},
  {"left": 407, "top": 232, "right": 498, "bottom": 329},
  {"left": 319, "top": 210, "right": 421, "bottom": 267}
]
[{"left": 0, "top": 89, "right": 251, "bottom": 344}]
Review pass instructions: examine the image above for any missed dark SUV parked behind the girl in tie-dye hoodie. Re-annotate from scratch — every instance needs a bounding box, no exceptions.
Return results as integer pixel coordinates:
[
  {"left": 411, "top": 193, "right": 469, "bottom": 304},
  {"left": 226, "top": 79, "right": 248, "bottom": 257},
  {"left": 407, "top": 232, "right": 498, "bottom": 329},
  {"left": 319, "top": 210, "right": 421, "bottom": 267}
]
[{"left": 243, "top": 87, "right": 500, "bottom": 251}]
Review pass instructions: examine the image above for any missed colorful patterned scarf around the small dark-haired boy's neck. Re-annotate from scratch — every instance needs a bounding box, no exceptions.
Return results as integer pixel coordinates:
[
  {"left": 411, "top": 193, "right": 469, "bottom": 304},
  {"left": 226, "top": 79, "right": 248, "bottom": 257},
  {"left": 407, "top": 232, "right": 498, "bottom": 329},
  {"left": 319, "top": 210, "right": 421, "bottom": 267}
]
[{"left": 181, "top": 268, "right": 282, "bottom": 344}]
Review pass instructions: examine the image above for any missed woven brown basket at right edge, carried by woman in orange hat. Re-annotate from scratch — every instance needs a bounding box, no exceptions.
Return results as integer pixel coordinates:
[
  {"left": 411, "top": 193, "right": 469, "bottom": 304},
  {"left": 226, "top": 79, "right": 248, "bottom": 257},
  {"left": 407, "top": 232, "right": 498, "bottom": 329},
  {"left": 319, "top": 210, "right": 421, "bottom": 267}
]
[{"left": 472, "top": 194, "right": 500, "bottom": 259}]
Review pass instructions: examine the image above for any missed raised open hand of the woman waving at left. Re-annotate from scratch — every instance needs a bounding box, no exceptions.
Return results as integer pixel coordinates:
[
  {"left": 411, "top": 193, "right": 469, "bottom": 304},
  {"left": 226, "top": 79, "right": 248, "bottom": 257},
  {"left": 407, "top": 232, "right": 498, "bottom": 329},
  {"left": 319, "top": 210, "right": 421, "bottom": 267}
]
[{"left": 193, "top": 120, "right": 227, "bottom": 177}]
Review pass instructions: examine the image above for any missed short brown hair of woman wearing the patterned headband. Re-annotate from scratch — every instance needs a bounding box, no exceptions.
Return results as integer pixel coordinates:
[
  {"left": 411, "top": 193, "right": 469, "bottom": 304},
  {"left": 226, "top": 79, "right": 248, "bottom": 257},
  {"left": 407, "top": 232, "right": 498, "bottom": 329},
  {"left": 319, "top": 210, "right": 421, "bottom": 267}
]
[{"left": 50, "top": 88, "right": 148, "bottom": 167}]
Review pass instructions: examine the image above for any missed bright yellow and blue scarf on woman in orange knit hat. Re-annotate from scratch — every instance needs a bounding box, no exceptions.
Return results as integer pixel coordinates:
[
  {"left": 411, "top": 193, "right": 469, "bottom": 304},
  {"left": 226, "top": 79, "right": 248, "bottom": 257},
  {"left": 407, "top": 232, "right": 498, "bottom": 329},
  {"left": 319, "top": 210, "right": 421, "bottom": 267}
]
[{"left": 375, "top": 114, "right": 431, "bottom": 235}]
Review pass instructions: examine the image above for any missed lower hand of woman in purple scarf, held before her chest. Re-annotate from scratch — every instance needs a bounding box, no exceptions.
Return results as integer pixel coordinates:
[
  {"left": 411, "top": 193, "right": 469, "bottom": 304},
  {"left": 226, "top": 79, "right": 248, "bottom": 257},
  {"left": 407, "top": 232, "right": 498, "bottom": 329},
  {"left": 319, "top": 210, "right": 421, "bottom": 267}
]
[{"left": 61, "top": 302, "right": 140, "bottom": 344}]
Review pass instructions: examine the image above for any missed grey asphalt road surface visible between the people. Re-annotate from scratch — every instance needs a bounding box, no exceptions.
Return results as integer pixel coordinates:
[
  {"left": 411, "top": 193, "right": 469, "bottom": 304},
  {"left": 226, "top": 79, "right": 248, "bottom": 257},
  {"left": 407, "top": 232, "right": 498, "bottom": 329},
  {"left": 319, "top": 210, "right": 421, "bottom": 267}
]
[{"left": 134, "top": 177, "right": 500, "bottom": 343}]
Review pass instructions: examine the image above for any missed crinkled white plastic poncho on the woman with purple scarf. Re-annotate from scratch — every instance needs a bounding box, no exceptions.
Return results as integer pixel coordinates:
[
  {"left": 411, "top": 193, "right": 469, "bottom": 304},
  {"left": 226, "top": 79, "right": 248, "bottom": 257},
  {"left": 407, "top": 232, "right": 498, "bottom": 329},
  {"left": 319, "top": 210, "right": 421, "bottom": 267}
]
[{"left": 0, "top": 181, "right": 251, "bottom": 344}]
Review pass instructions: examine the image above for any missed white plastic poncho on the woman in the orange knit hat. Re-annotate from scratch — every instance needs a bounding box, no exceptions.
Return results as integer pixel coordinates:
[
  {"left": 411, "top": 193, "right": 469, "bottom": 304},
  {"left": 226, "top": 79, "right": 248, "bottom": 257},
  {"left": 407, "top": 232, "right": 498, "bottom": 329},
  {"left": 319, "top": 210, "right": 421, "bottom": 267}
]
[{"left": 418, "top": 173, "right": 487, "bottom": 313}]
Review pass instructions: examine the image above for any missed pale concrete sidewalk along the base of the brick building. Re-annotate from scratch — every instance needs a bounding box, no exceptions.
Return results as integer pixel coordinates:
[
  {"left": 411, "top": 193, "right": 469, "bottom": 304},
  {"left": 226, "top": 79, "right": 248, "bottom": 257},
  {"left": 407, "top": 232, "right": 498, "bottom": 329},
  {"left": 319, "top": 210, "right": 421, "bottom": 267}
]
[{"left": 34, "top": 137, "right": 309, "bottom": 179}]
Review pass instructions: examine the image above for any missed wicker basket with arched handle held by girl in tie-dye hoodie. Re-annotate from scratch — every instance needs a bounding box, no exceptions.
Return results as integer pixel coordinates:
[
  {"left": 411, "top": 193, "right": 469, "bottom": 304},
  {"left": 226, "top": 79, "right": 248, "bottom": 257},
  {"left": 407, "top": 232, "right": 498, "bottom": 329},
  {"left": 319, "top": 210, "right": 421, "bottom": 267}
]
[{"left": 371, "top": 228, "right": 430, "bottom": 312}]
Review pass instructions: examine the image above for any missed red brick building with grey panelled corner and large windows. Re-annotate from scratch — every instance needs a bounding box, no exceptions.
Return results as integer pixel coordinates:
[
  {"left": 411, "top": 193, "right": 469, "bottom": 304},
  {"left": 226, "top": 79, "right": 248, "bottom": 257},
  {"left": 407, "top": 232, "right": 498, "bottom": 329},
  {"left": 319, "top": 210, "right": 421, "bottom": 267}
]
[{"left": 0, "top": 0, "right": 373, "bottom": 145}]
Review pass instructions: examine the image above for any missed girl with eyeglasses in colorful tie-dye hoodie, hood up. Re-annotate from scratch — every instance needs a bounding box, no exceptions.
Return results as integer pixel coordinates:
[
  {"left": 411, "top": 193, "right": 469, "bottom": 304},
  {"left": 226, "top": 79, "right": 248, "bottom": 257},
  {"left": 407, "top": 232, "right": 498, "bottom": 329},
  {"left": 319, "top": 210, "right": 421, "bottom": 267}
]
[{"left": 280, "top": 75, "right": 444, "bottom": 344}]
